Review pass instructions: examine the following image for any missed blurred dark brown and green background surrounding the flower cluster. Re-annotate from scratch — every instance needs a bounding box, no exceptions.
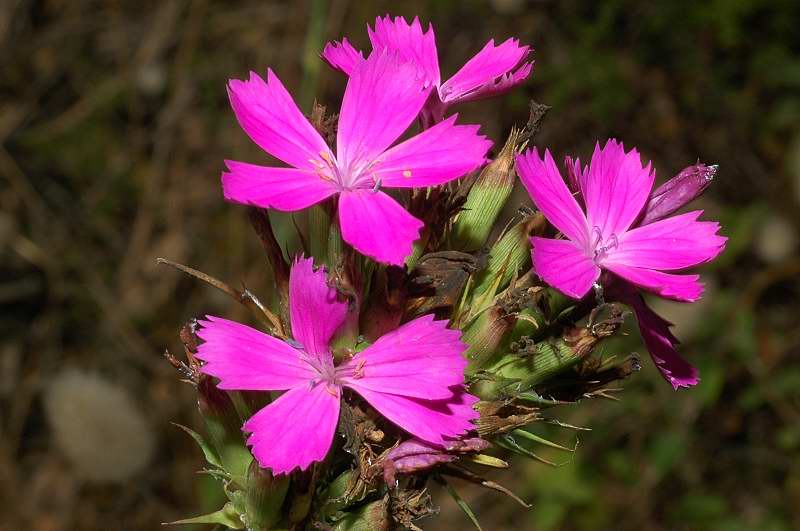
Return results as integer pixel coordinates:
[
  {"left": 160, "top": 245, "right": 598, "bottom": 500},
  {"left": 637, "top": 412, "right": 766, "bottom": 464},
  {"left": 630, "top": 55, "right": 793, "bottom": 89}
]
[{"left": 0, "top": 0, "right": 800, "bottom": 531}]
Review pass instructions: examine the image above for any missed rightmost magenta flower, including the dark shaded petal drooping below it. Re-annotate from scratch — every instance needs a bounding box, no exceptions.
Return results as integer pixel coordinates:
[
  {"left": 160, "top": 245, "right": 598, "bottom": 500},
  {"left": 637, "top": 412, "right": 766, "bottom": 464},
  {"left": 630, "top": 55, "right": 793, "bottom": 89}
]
[{"left": 517, "top": 140, "right": 727, "bottom": 389}]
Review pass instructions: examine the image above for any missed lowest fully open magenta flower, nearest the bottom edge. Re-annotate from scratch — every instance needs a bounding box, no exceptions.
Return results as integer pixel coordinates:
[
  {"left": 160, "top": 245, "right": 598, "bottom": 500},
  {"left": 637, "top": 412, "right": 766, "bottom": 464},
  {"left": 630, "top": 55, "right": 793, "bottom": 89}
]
[{"left": 197, "top": 259, "right": 478, "bottom": 474}]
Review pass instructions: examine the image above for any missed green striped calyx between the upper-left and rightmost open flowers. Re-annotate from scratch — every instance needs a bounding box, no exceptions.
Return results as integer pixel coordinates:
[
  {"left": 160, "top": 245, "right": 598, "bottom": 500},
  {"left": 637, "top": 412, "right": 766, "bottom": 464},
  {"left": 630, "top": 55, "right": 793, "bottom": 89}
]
[{"left": 452, "top": 129, "right": 521, "bottom": 251}]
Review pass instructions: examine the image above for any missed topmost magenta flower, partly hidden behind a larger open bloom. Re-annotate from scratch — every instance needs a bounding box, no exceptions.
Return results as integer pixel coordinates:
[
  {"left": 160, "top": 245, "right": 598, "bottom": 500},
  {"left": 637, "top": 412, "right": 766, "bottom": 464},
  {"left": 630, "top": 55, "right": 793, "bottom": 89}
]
[{"left": 322, "top": 15, "right": 533, "bottom": 125}]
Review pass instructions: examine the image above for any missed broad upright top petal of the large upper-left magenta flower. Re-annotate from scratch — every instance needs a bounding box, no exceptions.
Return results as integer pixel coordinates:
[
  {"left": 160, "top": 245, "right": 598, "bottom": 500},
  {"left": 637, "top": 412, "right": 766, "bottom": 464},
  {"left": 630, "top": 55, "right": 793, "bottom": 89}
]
[{"left": 336, "top": 50, "right": 431, "bottom": 170}]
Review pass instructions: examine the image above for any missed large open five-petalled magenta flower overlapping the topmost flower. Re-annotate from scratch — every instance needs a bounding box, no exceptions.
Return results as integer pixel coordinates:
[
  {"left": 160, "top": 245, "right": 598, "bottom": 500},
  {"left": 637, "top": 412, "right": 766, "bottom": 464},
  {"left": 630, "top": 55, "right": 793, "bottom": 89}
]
[{"left": 222, "top": 51, "right": 491, "bottom": 265}]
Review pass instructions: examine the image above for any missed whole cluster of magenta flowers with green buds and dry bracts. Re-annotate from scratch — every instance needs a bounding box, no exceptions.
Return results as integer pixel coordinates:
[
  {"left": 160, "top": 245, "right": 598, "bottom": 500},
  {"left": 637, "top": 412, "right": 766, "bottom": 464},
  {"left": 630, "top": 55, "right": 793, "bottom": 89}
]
[{"left": 167, "top": 16, "right": 726, "bottom": 529}]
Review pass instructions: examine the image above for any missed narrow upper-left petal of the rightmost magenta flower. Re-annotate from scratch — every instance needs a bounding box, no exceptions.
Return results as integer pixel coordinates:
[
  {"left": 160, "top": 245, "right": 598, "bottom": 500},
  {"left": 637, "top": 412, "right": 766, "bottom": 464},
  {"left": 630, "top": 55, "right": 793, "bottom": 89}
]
[{"left": 516, "top": 148, "right": 589, "bottom": 248}]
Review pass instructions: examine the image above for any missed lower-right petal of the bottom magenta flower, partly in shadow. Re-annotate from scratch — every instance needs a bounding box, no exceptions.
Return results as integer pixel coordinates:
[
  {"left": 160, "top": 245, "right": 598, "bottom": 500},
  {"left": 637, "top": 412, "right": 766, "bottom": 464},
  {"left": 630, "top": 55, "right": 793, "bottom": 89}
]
[{"left": 356, "top": 387, "right": 479, "bottom": 446}]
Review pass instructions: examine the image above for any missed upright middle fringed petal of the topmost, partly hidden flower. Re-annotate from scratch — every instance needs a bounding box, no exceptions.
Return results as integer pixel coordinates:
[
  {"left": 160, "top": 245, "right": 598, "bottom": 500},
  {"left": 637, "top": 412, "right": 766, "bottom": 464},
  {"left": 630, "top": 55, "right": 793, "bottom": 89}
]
[{"left": 367, "top": 16, "right": 439, "bottom": 85}]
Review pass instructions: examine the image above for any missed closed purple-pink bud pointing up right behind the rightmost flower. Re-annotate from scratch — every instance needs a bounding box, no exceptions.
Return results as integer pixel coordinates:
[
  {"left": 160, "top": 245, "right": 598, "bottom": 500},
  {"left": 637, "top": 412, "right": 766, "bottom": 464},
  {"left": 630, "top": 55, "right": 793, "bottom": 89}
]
[{"left": 639, "top": 162, "right": 718, "bottom": 225}]
